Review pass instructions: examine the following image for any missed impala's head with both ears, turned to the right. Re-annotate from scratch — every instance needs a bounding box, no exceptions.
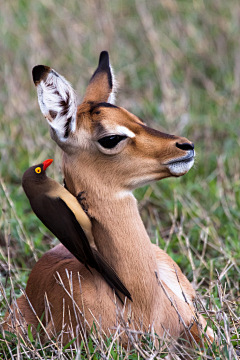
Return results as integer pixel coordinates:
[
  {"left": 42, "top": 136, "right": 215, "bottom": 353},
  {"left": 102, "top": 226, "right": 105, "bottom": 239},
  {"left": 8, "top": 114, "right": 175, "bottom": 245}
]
[{"left": 33, "top": 51, "right": 194, "bottom": 194}]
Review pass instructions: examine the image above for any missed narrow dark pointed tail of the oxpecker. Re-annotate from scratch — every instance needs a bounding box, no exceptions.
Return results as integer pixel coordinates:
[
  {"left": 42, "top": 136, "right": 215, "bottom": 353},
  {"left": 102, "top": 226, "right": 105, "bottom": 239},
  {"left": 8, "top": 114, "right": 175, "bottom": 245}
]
[{"left": 91, "top": 247, "right": 132, "bottom": 302}]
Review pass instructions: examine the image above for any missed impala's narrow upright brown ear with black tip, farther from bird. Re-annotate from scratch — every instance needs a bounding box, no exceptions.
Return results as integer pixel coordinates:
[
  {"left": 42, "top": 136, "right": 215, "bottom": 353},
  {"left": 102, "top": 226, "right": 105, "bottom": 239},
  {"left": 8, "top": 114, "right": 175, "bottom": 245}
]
[{"left": 83, "top": 51, "right": 117, "bottom": 104}]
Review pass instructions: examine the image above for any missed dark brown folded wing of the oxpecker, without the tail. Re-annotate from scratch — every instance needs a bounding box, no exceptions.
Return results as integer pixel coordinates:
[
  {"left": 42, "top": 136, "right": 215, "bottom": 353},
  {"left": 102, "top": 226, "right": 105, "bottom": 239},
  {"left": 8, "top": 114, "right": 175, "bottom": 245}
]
[{"left": 30, "top": 194, "right": 96, "bottom": 270}]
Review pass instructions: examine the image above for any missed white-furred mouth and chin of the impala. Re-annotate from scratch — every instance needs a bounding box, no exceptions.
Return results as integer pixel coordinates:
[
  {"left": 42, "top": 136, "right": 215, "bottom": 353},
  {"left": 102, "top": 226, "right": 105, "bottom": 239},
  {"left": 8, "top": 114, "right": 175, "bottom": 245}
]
[{"left": 164, "top": 150, "right": 195, "bottom": 176}]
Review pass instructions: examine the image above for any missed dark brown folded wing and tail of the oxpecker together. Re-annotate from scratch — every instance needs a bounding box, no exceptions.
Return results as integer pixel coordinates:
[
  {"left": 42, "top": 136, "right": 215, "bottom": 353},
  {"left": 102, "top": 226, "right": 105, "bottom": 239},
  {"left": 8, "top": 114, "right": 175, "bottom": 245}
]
[{"left": 30, "top": 194, "right": 132, "bottom": 301}]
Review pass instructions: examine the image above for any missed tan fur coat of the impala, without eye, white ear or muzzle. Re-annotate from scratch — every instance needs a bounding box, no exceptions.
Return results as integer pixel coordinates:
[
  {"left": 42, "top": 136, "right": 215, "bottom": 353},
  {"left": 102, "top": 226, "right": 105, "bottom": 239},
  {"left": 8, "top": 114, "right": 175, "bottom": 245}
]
[{"left": 4, "top": 55, "right": 214, "bottom": 343}]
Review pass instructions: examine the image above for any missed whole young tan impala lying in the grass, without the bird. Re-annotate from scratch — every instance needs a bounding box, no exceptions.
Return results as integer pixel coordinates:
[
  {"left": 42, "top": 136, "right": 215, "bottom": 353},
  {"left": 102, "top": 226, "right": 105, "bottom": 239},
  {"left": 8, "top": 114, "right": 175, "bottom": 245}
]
[{"left": 4, "top": 51, "right": 213, "bottom": 343}]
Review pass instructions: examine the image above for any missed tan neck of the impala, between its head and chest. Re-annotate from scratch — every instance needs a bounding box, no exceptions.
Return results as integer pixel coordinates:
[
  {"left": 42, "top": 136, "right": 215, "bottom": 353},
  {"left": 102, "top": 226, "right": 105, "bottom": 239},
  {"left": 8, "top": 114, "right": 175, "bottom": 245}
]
[{"left": 90, "top": 194, "right": 157, "bottom": 287}]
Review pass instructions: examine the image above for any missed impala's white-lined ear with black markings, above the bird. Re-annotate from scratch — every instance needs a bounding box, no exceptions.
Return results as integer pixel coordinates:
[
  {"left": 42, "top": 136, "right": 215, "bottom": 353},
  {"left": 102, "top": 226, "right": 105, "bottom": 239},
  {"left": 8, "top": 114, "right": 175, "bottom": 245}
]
[{"left": 32, "top": 65, "right": 77, "bottom": 141}]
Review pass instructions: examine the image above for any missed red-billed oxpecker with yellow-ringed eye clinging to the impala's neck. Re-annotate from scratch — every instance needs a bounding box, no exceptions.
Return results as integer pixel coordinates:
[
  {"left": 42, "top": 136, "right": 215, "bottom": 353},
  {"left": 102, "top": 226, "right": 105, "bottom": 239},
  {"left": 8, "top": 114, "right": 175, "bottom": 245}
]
[{"left": 22, "top": 159, "right": 132, "bottom": 301}]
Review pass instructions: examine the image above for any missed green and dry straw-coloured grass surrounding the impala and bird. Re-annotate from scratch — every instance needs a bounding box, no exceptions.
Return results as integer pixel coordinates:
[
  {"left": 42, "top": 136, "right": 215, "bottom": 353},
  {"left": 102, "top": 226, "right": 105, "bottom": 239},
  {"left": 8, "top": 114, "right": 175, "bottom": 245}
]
[{"left": 0, "top": 0, "right": 240, "bottom": 359}]
